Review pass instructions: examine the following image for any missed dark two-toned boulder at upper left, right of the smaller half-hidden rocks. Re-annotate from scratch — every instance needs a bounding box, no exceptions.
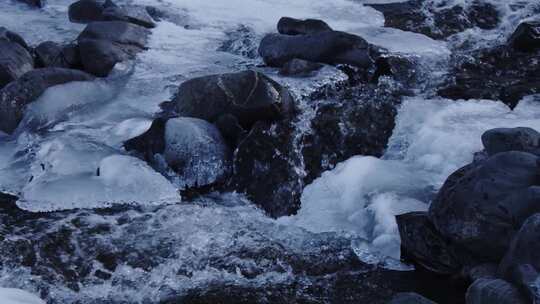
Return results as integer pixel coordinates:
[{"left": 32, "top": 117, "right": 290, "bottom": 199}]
[{"left": 77, "top": 21, "right": 150, "bottom": 77}]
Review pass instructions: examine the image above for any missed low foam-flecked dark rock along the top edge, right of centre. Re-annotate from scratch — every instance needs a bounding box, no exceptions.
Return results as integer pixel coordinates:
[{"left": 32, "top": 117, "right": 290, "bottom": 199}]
[{"left": 368, "top": 0, "right": 499, "bottom": 39}]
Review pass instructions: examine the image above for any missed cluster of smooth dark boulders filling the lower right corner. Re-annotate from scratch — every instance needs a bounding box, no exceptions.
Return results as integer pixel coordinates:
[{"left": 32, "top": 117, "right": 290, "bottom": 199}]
[{"left": 397, "top": 128, "right": 540, "bottom": 304}]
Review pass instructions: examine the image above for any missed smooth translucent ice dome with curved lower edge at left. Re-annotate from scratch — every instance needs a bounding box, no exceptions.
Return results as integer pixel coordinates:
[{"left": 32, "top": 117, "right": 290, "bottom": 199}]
[{"left": 18, "top": 154, "right": 181, "bottom": 211}]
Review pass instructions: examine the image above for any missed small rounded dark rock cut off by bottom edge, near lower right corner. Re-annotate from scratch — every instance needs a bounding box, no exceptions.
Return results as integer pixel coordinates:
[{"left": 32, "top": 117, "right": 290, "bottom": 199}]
[{"left": 466, "top": 279, "right": 529, "bottom": 304}]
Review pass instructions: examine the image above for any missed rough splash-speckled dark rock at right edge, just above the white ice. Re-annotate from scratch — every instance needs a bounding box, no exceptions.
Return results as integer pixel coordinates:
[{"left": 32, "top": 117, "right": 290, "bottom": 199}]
[{"left": 438, "top": 46, "right": 540, "bottom": 108}]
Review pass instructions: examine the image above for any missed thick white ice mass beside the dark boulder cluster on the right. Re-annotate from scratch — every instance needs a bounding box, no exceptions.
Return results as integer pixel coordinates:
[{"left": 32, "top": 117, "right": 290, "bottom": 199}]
[{"left": 286, "top": 96, "right": 540, "bottom": 258}]
